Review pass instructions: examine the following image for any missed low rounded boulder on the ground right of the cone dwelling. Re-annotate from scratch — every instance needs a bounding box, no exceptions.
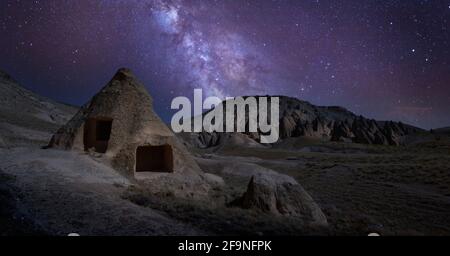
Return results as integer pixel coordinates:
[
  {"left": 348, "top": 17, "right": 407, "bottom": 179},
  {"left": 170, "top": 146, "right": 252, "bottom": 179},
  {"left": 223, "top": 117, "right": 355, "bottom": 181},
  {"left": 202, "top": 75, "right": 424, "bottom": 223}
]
[{"left": 231, "top": 173, "right": 327, "bottom": 226}]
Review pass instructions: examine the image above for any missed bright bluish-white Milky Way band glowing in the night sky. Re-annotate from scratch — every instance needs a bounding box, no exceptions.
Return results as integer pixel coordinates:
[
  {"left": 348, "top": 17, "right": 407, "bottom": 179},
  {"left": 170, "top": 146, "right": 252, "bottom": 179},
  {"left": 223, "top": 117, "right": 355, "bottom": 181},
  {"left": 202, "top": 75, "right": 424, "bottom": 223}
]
[{"left": 150, "top": 1, "right": 268, "bottom": 98}]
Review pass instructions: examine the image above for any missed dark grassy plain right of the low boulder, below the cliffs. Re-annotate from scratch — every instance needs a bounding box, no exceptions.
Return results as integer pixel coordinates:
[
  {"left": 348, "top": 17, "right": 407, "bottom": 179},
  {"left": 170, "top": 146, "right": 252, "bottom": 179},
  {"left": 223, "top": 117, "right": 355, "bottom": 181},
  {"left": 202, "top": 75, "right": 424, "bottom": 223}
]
[{"left": 201, "top": 135, "right": 450, "bottom": 235}]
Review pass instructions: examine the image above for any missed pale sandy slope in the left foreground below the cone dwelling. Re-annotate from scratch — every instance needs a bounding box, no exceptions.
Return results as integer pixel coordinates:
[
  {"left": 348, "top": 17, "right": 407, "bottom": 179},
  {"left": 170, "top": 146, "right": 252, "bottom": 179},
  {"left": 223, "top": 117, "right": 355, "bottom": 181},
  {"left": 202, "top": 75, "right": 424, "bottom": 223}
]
[{"left": 0, "top": 148, "right": 204, "bottom": 235}]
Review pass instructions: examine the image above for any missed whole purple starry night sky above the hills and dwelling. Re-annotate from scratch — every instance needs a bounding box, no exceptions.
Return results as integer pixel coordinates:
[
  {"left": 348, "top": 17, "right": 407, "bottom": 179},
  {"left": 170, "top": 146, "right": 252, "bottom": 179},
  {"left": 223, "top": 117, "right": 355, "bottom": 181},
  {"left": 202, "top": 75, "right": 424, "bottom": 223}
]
[{"left": 0, "top": 0, "right": 450, "bottom": 128}]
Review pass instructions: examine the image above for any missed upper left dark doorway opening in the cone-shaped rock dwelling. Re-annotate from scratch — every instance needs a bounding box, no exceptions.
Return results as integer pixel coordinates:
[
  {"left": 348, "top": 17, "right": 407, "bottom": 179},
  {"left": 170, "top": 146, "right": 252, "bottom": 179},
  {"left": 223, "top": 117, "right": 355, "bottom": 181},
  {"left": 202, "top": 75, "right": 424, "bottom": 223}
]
[{"left": 83, "top": 118, "right": 113, "bottom": 153}]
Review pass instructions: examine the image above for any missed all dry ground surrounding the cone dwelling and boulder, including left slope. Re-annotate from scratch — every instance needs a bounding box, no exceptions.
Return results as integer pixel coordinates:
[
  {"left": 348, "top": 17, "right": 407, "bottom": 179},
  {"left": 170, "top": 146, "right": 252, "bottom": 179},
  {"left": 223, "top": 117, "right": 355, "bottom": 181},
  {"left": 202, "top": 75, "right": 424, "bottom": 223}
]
[{"left": 0, "top": 69, "right": 450, "bottom": 235}]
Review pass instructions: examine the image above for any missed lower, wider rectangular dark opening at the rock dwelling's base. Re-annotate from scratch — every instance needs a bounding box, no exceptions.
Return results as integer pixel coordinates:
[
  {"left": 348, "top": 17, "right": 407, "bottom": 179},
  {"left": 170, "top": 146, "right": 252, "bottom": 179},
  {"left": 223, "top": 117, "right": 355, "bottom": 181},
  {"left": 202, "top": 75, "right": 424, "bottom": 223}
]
[{"left": 136, "top": 145, "right": 173, "bottom": 172}]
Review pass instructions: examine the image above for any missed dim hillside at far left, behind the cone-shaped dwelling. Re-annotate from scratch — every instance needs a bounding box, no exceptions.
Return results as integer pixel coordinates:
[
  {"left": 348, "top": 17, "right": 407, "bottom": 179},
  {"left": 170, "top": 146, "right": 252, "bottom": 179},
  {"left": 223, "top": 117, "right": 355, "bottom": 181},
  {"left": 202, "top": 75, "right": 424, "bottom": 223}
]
[{"left": 0, "top": 70, "right": 77, "bottom": 146}]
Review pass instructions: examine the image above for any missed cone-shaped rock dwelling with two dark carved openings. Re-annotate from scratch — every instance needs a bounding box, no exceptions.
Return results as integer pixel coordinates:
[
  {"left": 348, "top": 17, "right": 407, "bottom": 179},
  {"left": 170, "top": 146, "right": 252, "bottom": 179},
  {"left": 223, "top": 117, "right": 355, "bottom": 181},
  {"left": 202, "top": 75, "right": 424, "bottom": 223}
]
[{"left": 49, "top": 69, "right": 201, "bottom": 176}]
